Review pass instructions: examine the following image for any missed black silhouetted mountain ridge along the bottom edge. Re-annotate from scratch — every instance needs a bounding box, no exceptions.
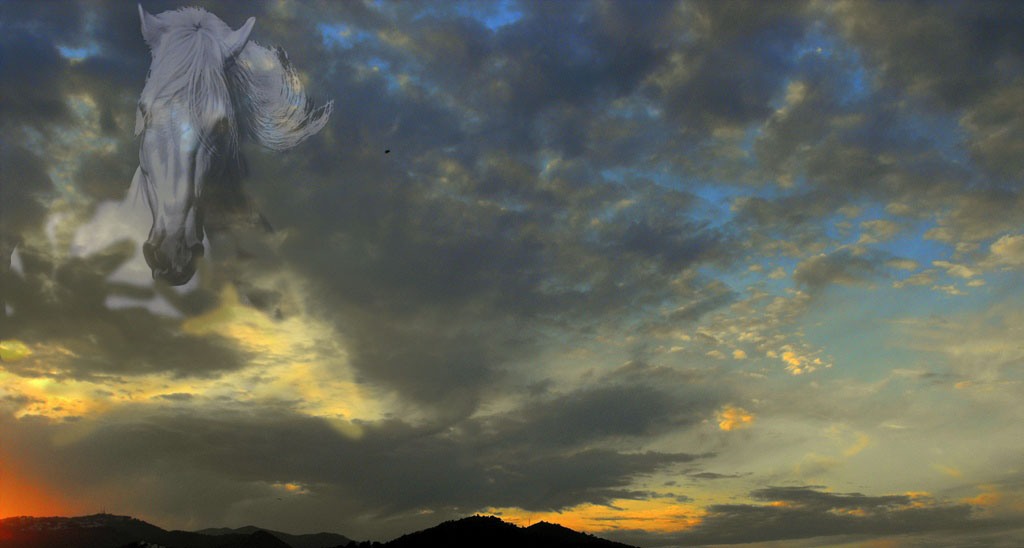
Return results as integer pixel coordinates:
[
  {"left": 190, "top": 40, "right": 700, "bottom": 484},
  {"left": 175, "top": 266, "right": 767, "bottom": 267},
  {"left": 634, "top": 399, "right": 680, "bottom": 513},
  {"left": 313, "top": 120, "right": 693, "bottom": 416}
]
[{"left": 0, "top": 514, "right": 630, "bottom": 548}]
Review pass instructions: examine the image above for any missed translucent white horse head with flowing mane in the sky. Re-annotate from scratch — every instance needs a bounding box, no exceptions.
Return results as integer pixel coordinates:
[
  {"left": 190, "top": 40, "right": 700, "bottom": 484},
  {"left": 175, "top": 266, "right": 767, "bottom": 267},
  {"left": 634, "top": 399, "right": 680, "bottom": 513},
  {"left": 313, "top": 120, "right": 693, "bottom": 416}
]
[{"left": 132, "top": 6, "right": 332, "bottom": 286}]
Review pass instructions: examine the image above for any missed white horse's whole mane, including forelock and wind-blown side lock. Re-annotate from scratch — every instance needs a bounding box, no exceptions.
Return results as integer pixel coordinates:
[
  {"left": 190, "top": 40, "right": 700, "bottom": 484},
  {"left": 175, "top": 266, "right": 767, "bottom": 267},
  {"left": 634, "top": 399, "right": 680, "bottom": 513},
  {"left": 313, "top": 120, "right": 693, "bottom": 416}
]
[{"left": 135, "top": 7, "right": 334, "bottom": 151}]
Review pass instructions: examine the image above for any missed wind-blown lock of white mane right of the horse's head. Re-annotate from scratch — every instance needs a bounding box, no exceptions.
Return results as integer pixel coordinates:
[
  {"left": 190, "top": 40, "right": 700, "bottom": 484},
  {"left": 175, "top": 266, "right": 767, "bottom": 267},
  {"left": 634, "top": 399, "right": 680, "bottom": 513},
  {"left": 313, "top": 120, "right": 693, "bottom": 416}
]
[{"left": 227, "top": 41, "right": 334, "bottom": 151}]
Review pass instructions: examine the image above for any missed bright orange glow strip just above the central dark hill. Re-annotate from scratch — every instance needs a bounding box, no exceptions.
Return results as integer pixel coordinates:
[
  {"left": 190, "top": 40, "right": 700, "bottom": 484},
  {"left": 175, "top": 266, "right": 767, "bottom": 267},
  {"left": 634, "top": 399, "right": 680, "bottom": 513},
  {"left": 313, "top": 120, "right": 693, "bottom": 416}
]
[{"left": 487, "top": 498, "right": 707, "bottom": 533}]
